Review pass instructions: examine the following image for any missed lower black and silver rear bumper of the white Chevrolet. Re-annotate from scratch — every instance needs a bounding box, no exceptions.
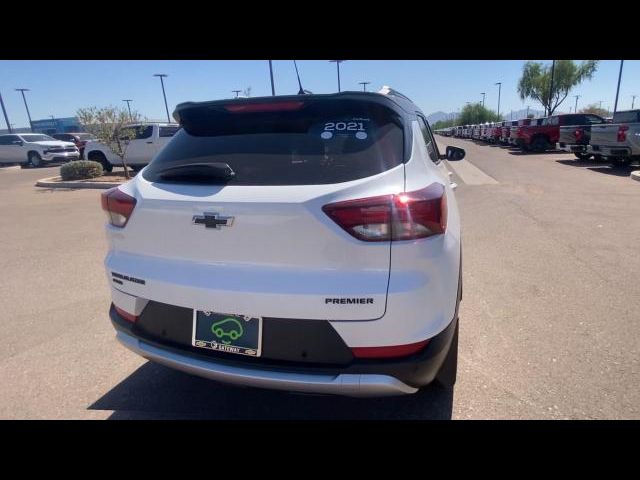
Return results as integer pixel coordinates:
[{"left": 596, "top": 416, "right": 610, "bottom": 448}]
[{"left": 110, "top": 306, "right": 457, "bottom": 397}]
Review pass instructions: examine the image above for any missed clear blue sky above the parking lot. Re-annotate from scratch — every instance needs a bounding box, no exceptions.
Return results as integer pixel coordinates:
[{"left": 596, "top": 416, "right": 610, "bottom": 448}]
[{"left": 0, "top": 60, "right": 640, "bottom": 128}]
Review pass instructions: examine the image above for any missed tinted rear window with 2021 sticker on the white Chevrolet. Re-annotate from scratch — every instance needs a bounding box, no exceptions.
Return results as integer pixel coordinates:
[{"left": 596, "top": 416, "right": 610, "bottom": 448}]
[{"left": 143, "top": 100, "right": 404, "bottom": 185}]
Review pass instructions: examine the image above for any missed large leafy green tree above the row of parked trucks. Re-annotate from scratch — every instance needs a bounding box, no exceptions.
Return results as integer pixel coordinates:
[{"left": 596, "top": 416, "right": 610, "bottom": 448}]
[{"left": 518, "top": 60, "right": 598, "bottom": 115}]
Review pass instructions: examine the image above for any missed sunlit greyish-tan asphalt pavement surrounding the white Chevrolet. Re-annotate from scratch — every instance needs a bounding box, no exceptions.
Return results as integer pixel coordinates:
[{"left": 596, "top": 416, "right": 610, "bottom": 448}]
[{"left": 0, "top": 146, "right": 640, "bottom": 419}]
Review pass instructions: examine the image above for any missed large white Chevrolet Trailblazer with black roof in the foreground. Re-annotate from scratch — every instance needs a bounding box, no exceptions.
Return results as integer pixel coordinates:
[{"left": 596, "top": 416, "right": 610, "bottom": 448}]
[{"left": 102, "top": 88, "right": 464, "bottom": 396}]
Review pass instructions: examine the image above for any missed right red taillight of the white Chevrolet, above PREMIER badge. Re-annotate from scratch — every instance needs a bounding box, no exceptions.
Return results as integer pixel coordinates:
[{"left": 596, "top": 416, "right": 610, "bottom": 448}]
[{"left": 322, "top": 183, "right": 447, "bottom": 242}]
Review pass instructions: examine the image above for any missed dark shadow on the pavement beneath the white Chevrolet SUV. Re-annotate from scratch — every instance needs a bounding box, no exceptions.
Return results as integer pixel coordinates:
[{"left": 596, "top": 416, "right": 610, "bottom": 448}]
[{"left": 89, "top": 362, "right": 454, "bottom": 420}]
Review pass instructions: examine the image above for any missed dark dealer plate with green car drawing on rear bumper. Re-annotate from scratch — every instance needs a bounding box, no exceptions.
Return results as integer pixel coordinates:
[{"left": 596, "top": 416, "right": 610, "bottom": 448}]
[{"left": 191, "top": 310, "right": 262, "bottom": 357}]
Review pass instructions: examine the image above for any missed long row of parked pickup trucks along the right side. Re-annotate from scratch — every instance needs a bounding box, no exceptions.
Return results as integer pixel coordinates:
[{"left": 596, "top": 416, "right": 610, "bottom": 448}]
[{"left": 436, "top": 110, "right": 640, "bottom": 163}]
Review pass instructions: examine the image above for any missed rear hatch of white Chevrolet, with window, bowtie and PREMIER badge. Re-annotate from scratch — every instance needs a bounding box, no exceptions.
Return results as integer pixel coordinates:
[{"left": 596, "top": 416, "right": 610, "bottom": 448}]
[{"left": 106, "top": 95, "right": 407, "bottom": 320}]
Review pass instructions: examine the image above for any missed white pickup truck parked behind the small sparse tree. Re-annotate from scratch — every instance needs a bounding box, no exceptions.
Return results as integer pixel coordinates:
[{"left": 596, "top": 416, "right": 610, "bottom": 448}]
[{"left": 84, "top": 123, "right": 180, "bottom": 172}]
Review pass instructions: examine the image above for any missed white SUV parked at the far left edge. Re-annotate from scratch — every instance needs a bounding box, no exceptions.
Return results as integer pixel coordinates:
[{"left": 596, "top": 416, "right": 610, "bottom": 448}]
[{"left": 0, "top": 133, "right": 80, "bottom": 167}]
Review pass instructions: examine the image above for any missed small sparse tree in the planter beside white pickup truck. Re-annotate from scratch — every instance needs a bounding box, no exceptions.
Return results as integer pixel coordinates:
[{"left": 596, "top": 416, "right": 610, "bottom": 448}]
[{"left": 76, "top": 106, "right": 142, "bottom": 178}]
